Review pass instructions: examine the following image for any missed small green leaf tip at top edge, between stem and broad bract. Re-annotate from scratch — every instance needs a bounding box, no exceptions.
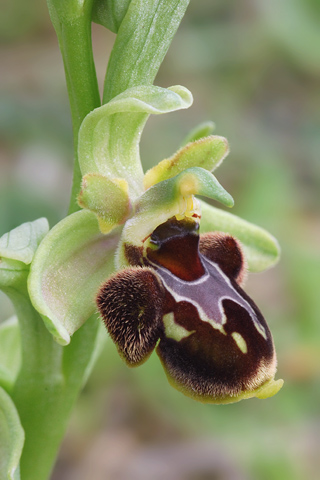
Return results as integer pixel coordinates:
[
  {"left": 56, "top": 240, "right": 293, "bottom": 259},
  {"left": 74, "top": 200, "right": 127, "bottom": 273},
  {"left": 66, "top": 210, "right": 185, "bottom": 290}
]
[{"left": 92, "top": 0, "right": 131, "bottom": 33}]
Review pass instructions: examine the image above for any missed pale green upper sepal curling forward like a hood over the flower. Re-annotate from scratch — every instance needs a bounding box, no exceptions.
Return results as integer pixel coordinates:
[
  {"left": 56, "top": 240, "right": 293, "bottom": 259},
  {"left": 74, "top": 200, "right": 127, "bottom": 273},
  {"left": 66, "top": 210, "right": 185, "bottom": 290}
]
[{"left": 79, "top": 86, "right": 192, "bottom": 197}]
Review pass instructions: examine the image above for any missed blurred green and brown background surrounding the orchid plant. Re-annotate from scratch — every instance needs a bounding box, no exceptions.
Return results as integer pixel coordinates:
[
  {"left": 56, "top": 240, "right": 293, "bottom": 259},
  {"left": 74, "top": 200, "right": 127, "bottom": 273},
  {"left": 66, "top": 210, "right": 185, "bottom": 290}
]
[{"left": 0, "top": 0, "right": 320, "bottom": 480}]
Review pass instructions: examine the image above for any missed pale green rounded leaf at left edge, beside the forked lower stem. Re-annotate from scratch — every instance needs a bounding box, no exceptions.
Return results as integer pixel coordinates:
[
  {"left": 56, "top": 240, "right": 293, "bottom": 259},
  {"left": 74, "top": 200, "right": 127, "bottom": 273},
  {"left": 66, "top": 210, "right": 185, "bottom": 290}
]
[{"left": 0, "top": 317, "right": 21, "bottom": 391}]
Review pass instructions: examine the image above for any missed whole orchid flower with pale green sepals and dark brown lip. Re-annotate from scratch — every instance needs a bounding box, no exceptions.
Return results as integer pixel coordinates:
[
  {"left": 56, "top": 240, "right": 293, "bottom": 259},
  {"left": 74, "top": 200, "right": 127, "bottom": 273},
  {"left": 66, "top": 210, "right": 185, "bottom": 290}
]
[{"left": 28, "top": 86, "right": 283, "bottom": 403}]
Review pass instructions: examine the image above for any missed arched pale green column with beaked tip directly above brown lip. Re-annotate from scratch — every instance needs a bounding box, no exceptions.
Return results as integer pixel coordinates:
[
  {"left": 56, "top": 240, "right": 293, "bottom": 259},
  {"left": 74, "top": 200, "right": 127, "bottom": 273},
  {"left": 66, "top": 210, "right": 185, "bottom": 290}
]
[{"left": 117, "top": 167, "right": 233, "bottom": 268}]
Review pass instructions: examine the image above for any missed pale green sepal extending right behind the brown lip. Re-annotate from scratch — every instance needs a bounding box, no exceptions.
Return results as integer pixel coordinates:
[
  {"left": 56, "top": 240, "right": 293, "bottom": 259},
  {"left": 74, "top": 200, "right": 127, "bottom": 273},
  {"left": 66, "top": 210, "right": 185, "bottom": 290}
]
[{"left": 200, "top": 202, "right": 280, "bottom": 272}]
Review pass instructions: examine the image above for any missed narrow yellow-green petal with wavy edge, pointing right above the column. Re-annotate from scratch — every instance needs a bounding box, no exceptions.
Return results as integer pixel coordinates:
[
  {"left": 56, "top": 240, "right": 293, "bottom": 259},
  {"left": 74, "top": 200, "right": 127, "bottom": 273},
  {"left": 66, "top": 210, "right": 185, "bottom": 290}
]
[{"left": 143, "top": 135, "right": 229, "bottom": 189}]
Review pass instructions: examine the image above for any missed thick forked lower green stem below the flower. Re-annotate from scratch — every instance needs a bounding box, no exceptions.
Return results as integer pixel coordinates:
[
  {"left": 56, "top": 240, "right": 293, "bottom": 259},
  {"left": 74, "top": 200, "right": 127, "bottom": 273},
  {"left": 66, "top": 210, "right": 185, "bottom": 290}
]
[{"left": 6, "top": 288, "right": 99, "bottom": 480}]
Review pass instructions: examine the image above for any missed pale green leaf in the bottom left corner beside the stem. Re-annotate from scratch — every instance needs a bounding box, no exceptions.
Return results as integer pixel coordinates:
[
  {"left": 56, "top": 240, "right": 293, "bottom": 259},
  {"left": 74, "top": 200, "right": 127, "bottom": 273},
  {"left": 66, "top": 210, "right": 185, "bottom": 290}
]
[{"left": 0, "top": 387, "right": 24, "bottom": 480}]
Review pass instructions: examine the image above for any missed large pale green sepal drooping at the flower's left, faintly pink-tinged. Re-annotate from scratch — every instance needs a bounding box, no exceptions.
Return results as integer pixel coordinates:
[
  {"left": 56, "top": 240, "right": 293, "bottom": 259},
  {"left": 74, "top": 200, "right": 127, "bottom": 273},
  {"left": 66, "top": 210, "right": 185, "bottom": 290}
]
[{"left": 28, "top": 210, "right": 119, "bottom": 345}]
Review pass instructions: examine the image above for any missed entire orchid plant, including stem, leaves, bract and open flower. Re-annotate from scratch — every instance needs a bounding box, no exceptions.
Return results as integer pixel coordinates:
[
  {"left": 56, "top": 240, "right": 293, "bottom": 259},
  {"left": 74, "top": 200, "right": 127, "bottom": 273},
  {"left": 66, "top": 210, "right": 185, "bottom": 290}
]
[{"left": 0, "top": 0, "right": 283, "bottom": 480}]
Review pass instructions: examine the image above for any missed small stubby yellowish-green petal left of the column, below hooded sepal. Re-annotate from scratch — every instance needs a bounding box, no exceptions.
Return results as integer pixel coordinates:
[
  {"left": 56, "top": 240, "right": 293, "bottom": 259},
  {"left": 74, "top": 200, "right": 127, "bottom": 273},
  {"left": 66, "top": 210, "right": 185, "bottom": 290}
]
[{"left": 78, "top": 173, "right": 130, "bottom": 233}]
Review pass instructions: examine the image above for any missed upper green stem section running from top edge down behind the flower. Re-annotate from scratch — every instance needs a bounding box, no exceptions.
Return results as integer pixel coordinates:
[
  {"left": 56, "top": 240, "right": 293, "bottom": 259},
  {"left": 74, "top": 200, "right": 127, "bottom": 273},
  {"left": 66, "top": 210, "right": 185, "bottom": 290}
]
[{"left": 48, "top": 0, "right": 101, "bottom": 213}]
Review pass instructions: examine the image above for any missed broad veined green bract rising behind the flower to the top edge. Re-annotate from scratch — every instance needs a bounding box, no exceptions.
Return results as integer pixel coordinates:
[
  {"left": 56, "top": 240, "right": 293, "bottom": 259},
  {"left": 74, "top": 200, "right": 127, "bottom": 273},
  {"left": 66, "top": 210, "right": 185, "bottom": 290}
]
[{"left": 103, "top": 0, "right": 189, "bottom": 103}]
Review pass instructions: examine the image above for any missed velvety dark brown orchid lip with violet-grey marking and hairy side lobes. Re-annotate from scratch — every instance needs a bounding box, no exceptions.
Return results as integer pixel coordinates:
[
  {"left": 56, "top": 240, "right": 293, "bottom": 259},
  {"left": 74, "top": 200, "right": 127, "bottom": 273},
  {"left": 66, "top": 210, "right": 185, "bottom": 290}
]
[{"left": 97, "top": 213, "right": 282, "bottom": 403}]
